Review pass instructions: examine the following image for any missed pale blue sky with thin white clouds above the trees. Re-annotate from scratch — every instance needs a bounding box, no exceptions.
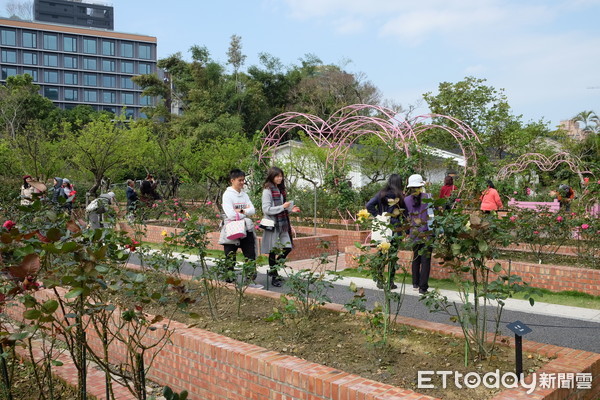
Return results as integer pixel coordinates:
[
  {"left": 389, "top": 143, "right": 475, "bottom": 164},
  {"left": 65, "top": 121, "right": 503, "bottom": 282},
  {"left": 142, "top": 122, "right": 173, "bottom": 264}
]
[{"left": 0, "top": 0, "right": 600, "bottom": 128}]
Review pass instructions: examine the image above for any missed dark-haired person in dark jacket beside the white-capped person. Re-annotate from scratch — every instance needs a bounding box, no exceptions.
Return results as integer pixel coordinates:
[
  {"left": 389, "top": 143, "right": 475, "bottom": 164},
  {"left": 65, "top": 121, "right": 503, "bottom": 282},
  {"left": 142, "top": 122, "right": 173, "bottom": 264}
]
[{"left": 366, "top": 174, "right": 406, "bottom": 289}]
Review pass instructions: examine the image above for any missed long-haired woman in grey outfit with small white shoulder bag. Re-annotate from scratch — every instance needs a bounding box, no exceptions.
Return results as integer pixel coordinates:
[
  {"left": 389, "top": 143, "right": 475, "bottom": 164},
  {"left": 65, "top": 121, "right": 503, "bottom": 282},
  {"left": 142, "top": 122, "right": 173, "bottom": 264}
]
[{"left": 261, "top": 167, "right": 300, "bottom": 287}]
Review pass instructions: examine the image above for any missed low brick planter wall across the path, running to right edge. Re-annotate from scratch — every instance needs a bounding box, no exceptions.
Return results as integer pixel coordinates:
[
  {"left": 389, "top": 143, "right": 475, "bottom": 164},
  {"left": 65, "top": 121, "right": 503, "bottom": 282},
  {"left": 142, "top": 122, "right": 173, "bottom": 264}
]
[{"left": 345, "top": 247, "right": 600, "bottom": 296}]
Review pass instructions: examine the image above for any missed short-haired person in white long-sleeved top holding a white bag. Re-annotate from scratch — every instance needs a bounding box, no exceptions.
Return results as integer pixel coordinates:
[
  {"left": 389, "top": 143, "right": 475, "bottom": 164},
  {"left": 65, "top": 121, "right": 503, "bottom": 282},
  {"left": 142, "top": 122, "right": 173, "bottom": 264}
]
[{"left": 219, "top": 169, "right": 262, "bottom": 287}]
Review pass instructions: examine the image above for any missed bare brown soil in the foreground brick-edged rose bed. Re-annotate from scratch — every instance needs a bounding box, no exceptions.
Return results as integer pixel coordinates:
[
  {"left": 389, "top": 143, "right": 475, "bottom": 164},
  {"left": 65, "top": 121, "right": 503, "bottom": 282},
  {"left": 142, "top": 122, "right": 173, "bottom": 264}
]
[{"left": 115, "top": 279, "right": 549, "bottom": 400}]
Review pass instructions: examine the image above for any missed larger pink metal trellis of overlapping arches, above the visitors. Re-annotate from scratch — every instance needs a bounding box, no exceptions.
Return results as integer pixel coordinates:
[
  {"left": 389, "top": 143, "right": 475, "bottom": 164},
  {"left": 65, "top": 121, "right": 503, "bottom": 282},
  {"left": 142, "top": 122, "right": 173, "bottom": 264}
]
[{"left": 257, "top": 104, "right": 481, "bottom": 195}]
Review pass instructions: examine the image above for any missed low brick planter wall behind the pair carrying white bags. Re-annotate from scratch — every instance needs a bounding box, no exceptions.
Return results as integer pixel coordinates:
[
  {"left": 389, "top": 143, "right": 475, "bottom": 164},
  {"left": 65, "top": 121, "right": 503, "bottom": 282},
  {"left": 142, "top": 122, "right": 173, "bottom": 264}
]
[{"left": 120, "top": 222, "right": 338, "bottom": 261}]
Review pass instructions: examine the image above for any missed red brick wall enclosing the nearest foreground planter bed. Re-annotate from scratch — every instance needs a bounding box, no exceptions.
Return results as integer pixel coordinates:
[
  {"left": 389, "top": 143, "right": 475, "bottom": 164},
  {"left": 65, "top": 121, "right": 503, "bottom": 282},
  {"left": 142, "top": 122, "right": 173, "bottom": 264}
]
[{"left": 7, "top": 289, "right": 600, "bottom": 400}]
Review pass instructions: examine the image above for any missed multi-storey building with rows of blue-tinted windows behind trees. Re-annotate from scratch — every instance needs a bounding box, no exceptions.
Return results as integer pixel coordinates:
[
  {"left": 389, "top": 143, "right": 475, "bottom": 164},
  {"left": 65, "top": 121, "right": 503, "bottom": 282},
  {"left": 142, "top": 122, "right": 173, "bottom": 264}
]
[{"left": 0, "top": 0, "right": 156, "bottom": 118}]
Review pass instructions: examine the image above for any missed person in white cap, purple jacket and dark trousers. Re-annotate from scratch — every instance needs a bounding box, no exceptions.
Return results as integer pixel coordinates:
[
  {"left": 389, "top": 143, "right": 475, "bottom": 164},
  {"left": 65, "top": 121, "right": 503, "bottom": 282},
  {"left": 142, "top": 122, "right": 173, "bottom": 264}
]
[{"left": 404, "top": 174, "right": 433, "bottom": 294}]
